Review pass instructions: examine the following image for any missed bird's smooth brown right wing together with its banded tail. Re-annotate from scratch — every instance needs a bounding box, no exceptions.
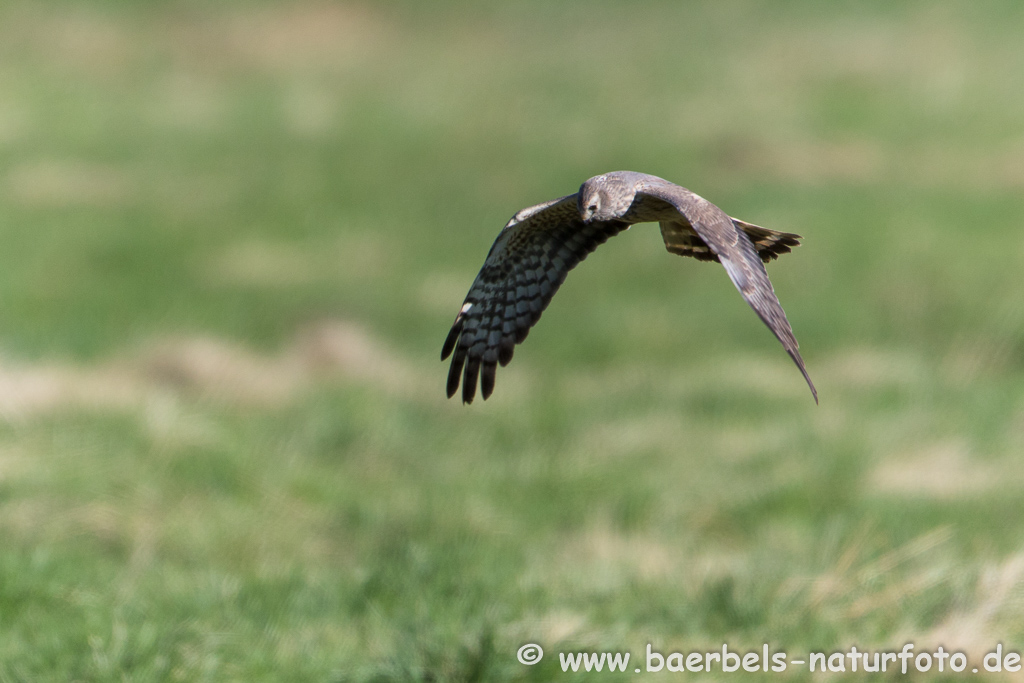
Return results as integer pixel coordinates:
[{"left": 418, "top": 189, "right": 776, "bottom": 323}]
[{"left": 637, "top": 180, "right": 818, "bottom": 402}]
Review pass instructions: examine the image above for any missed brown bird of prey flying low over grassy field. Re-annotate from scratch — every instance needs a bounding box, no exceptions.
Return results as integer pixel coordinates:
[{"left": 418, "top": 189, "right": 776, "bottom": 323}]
[{"left": 441, "top": 171, "right": 818, "bottom": 403}]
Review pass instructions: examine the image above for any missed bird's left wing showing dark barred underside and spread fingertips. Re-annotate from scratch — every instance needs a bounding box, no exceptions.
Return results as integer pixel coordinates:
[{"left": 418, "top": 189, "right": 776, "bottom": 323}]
[{"left": 441, "top": 195, "right": 629, "bottom": 403}]
